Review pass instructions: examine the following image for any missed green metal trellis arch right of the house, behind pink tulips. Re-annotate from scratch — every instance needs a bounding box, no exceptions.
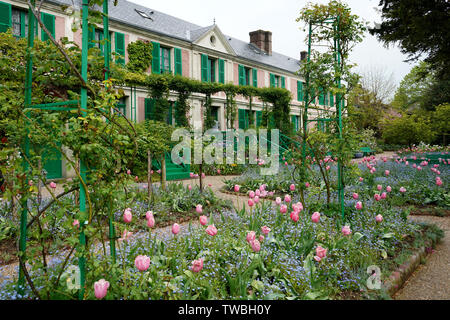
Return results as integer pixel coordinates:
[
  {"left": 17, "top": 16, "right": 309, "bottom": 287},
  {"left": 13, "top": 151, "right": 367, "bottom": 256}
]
[{"left": 302, "top": 15, "right": 345, "bottom": 221}]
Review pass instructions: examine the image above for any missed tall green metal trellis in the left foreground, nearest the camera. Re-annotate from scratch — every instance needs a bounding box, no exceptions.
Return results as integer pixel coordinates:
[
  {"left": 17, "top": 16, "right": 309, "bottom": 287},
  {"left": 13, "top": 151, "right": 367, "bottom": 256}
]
[{"left": 17, "top": 0, "right": 116, "bottom": 299}]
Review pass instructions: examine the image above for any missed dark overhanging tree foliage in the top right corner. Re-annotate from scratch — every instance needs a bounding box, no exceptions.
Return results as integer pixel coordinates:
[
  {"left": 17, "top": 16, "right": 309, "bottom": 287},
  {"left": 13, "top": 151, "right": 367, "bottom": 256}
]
[{"left": 369, "top": 0, "right": 450, "bottom": 79}]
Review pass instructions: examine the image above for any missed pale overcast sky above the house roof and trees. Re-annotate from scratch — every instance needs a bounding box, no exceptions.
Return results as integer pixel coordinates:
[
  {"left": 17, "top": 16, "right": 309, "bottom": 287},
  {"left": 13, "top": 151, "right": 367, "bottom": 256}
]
[{"left": 128, "top": 0, "right": 414, "bottom": 89}]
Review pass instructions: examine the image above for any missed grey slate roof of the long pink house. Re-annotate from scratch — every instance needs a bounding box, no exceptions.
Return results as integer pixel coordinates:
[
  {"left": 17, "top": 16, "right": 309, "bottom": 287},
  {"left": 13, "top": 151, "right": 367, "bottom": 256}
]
[{"left": 49, "top": 0, "right": 300, "bottom": 73}]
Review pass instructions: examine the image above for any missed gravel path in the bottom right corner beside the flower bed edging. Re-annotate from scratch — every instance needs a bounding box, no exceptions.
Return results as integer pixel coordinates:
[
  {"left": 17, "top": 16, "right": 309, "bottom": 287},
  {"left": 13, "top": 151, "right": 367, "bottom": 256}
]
[{"left": 393, "top": 216, "right": 450, "bottom": 300}]
